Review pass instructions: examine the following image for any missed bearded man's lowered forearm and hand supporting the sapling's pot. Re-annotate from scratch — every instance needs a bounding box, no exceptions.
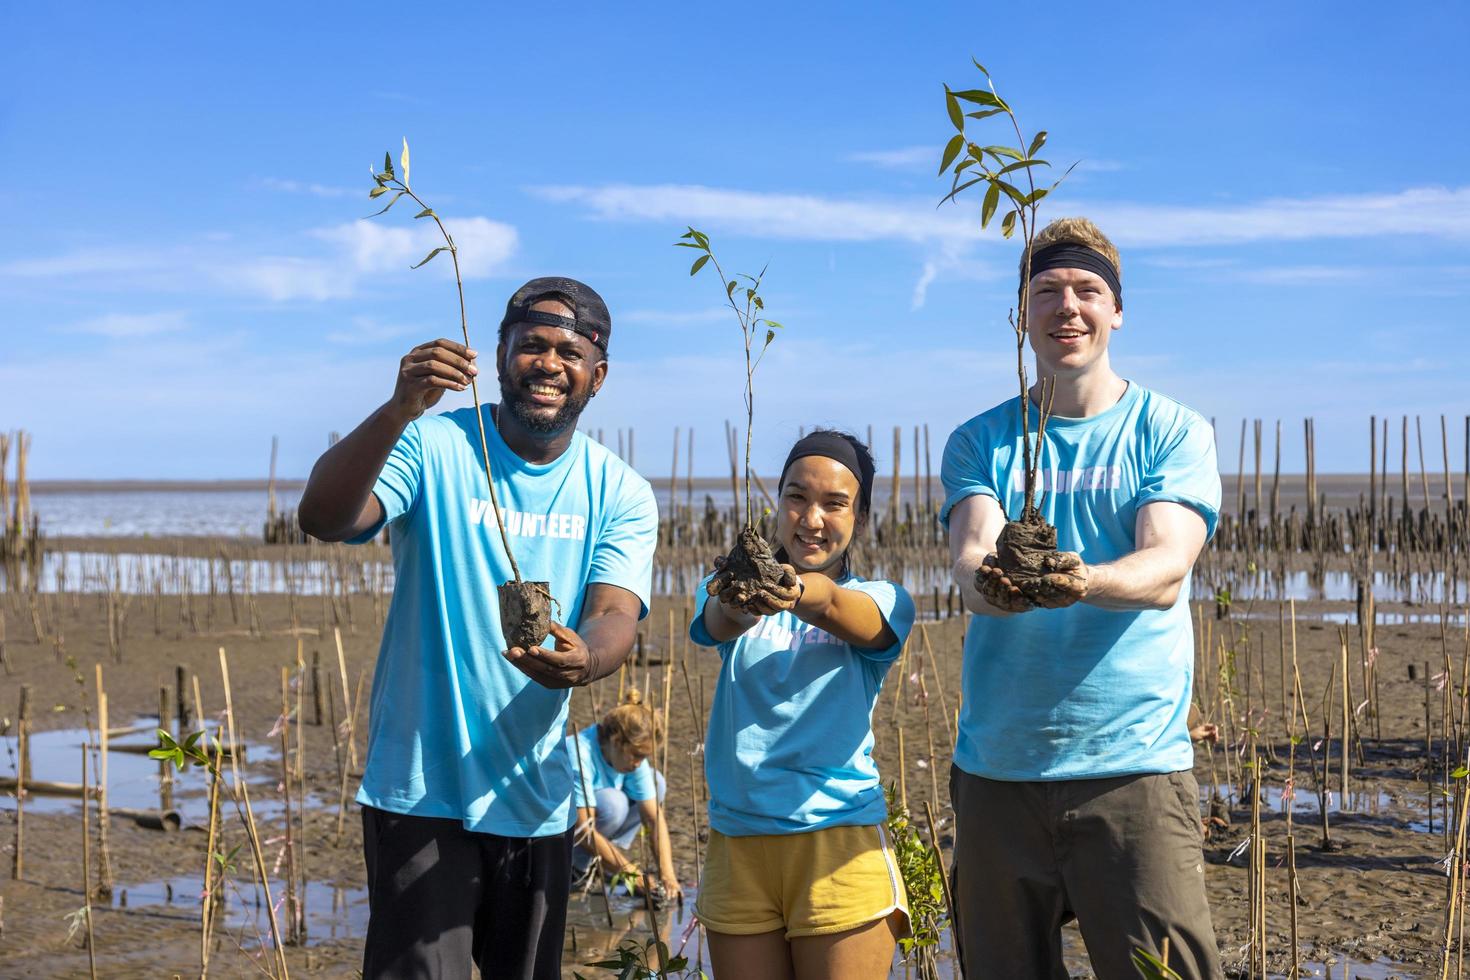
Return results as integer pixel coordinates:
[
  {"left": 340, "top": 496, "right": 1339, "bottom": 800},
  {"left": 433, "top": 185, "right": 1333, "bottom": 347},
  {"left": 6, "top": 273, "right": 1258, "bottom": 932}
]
[{"left": 504, "top": 582, "right": 642, "bottom": 691}]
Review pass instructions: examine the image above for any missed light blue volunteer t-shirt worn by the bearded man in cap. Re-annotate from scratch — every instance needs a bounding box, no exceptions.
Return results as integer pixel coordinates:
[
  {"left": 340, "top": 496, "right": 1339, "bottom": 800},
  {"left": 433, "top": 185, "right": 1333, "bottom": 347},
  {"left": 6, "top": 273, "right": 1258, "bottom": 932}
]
[{"left": 348, "top": 406, "right": 659, "bottom": 837}]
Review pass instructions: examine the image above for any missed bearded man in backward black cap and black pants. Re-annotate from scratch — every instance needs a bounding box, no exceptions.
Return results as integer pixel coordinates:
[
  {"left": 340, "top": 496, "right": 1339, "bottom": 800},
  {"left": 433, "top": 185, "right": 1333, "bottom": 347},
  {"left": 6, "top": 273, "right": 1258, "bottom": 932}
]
[{"left": 298, "top": 278, "right": 659, "bottom": 980}]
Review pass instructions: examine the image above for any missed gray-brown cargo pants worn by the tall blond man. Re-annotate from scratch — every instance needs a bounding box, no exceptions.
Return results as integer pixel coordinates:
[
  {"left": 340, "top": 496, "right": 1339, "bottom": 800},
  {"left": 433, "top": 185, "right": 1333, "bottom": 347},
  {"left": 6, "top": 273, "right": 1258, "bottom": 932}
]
[{"left": 950, "top": 768, "right": 1222, "bottom": 980}]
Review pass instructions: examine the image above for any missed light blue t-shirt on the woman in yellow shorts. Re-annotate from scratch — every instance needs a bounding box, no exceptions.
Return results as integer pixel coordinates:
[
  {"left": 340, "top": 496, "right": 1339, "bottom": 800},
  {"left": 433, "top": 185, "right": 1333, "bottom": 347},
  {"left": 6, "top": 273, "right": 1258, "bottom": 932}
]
[{"left": 689, "top": 576, "right": 914, "bottom": 837}]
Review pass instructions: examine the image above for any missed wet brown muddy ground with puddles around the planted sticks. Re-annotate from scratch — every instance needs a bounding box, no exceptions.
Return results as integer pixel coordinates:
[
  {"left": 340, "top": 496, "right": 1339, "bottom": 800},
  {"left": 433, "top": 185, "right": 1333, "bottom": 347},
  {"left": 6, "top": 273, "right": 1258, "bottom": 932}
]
[{"left": 0, "top": 549, "right": 1466, "bottom": 979}]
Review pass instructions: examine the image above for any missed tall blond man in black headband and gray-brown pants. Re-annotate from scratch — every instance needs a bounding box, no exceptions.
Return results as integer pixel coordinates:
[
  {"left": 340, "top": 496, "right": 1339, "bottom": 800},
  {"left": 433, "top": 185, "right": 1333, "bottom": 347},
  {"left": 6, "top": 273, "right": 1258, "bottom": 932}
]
[{"left": 941, "top": 217, "right": 1222, "bottom": 980}]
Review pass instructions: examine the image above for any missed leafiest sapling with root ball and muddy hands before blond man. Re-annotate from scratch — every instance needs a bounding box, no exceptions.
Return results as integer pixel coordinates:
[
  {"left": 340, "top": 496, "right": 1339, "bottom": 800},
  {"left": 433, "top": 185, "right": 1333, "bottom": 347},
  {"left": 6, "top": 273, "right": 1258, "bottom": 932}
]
[{"left": 939, "top": 62, "right": 1085, "bottom": 611}]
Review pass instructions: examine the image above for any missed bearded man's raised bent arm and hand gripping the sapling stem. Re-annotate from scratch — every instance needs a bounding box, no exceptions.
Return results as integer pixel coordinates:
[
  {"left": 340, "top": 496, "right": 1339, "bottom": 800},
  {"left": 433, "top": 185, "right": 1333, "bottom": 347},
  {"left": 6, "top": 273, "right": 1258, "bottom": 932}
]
[{"left": 295, "top": 333, "right": 478, "bottom": 541}]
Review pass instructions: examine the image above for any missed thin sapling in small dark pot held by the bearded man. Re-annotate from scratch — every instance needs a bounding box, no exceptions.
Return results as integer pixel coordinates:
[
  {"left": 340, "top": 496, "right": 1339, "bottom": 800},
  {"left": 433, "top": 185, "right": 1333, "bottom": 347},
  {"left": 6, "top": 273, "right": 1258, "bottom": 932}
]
[{"left": 368, "top": 140, "right": 553, "bottom": 649}]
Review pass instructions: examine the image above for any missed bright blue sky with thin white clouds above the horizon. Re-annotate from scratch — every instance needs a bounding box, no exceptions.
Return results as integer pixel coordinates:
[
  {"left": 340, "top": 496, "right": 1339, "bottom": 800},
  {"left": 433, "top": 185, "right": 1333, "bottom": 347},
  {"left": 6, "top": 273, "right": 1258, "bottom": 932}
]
[{"left": 0, "top": 3, "right": 1470, "bottom": 479}]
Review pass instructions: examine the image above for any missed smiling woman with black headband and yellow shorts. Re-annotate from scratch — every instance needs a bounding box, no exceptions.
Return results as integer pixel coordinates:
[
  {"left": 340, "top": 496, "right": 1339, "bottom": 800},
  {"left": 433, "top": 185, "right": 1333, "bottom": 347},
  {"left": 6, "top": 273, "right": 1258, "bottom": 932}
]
[{"left": 689, "top": 430, "right": 914, "bottom": 980}]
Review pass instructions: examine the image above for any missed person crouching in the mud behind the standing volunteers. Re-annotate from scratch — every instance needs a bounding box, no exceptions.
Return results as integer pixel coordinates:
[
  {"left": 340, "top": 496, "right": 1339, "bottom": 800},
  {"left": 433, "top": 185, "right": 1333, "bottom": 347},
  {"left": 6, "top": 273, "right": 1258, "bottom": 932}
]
[{"left": 566, "top": 688, "right": 684, "bottom": 901}]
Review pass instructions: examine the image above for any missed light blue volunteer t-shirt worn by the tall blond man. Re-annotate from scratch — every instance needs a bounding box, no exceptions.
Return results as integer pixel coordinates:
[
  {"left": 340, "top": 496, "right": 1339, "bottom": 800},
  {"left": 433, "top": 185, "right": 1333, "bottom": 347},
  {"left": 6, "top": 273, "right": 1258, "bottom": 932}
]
[{"left": 941, "top": 383, "right": 1220, "bottom": 780}]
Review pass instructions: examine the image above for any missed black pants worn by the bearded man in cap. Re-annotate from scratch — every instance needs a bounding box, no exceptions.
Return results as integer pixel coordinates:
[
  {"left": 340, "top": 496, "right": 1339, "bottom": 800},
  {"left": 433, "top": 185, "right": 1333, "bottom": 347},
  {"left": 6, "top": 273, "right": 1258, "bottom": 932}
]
[{"left": 363, "top": 807, "right": 572, "bottom": 980}]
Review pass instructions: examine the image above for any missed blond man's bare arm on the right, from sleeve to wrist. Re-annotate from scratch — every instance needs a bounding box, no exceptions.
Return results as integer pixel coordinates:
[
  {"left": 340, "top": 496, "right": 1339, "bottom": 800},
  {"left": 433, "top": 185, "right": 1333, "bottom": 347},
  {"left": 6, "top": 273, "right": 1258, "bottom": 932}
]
[{"left": 1080, "top": 501, "right": 1207, "bottom": 610}]
